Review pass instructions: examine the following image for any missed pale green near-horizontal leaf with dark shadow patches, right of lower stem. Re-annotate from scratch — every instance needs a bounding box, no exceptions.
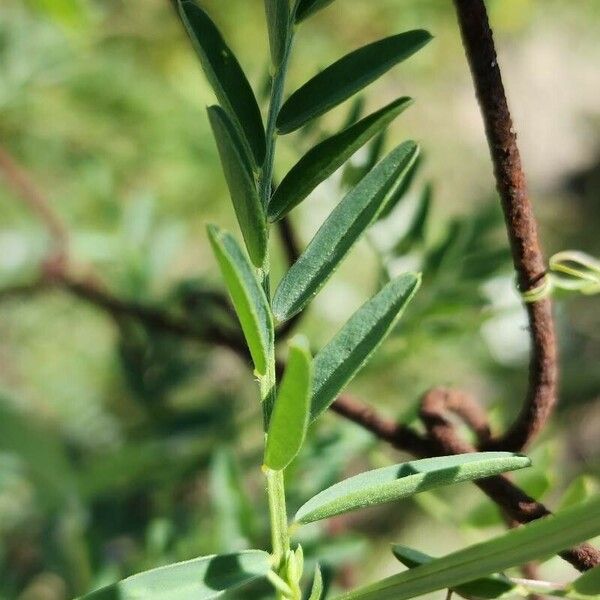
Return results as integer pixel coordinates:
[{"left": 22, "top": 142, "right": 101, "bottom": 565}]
[{"left": 295, "top": 452, "right": 531, "bottom": 523}]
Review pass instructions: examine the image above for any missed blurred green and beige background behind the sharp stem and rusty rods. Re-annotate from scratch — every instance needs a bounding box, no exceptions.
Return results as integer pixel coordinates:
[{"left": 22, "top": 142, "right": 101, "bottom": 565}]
[{"left": 0, "top": 0, "right": 600, "bottom": 600}]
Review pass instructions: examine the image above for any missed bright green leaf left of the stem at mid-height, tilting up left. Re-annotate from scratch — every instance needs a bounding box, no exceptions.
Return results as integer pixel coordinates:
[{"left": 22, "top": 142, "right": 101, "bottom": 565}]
[{"left": 207, "top": 225, "right": 274, "bottom": 375}]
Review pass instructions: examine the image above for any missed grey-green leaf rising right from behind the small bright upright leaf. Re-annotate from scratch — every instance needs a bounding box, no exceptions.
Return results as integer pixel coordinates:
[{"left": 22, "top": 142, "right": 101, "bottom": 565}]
[{"left": 311, "top": 273, "right": 421, "bottom": 419}]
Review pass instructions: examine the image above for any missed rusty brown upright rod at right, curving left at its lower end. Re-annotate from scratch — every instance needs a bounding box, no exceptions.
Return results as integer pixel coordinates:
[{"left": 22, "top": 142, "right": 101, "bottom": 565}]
[{"left": 454, "top": 0, "right": 558, "bottom": 451}]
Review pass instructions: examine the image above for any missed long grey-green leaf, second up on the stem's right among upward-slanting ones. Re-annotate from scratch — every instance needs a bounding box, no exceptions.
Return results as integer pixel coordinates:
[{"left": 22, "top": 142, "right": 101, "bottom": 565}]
[{"left": 273, "top": 142, "right": 418, "bottom": 321}]
